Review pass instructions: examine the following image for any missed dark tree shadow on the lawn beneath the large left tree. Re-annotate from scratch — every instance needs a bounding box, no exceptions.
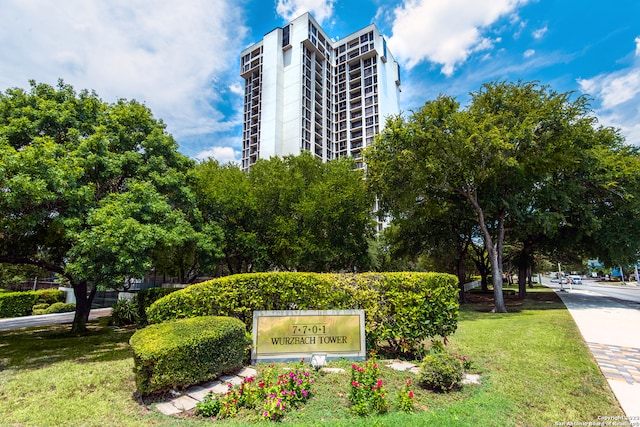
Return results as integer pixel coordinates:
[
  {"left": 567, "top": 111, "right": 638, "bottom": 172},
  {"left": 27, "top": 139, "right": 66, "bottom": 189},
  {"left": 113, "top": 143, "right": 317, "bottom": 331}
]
[{"left": 0, "top": 321, "right": 134, "bottom": 370}]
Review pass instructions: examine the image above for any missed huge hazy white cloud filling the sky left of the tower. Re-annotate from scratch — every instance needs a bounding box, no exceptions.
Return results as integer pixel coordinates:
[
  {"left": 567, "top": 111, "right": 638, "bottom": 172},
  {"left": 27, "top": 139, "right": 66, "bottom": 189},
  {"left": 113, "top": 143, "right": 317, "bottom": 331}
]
[{"left": 0, "top": 0, "right": 247, "bottom": 144}]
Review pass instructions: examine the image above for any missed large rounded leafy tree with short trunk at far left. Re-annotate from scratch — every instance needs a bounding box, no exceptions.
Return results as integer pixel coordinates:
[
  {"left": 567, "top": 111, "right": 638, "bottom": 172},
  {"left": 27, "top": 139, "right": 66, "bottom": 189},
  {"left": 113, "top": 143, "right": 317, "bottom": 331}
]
[{"left": 0, "top": 81, "right": 215, "bottom": 331}]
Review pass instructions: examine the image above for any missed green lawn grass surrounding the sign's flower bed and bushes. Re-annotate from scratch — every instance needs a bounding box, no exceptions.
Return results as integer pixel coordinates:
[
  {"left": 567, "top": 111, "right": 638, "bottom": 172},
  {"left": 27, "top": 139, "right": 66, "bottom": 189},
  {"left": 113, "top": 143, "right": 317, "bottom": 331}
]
[{"left": 0, "top": 288, "right": 623, "bottom": 427}]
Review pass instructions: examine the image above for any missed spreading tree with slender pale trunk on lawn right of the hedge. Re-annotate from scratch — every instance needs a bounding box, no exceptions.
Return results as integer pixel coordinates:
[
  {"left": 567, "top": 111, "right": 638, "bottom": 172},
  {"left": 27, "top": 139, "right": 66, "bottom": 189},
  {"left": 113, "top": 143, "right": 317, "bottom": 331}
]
[{"left": 366, "top": 82, "right": 632, "bottom": 312}]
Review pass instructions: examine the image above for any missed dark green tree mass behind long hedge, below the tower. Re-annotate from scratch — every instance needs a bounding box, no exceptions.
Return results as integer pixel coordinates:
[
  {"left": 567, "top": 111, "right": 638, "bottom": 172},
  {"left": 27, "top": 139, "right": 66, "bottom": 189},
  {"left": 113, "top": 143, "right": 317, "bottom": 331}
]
[{"left": 192, "top": 152, "right": 374, "bottom": 273}]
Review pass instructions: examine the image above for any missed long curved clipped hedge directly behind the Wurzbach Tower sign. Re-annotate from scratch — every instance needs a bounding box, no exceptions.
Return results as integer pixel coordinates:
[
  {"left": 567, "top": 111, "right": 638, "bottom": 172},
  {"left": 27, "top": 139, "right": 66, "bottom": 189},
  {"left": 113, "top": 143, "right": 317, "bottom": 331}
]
[{"left": 147, "top": 273, "right": 459, "bottom": 353}]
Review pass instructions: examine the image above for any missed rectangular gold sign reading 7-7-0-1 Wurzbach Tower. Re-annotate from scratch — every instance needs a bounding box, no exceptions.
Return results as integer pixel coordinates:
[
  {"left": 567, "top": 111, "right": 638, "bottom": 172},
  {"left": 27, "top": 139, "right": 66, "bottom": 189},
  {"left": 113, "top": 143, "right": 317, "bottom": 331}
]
[{"left": 251, "top": 310, "right": 366, "bottom": 363}]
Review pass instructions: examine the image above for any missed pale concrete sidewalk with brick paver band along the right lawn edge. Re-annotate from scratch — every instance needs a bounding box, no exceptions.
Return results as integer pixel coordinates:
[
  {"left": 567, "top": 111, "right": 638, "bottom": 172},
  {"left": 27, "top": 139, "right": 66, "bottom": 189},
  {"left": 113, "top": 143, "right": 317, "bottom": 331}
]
[{"left": 551, "top": 286, "right": 640, "bottom": 422}]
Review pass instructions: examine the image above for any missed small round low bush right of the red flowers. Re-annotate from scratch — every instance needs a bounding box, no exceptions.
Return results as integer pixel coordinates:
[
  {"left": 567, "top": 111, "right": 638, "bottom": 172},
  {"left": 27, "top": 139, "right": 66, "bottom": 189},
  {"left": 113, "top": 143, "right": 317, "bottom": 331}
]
[{"left": 419, "top": 352, "right": 464, "bottom": 393}]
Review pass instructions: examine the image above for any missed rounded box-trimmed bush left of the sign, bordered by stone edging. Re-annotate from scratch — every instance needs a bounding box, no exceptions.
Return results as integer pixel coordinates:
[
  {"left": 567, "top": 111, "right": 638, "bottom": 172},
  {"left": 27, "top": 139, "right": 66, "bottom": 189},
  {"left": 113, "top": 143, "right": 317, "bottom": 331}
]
[{"left": 129, "top": 316, "right": 249, "bottom": 395}]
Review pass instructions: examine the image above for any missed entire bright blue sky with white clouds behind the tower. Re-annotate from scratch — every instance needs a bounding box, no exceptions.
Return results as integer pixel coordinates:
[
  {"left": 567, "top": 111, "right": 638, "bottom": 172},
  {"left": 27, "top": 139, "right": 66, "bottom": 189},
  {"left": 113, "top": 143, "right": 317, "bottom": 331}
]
[{"left": 0, "top": 0, "right": 640, "bottom": 162}]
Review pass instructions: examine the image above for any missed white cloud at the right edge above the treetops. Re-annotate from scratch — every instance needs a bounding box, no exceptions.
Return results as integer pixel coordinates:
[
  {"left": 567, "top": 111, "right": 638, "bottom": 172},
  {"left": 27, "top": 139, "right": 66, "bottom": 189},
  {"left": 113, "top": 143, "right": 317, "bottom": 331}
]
[{"left": 578, "top": 37, "right": 640, "bottom": 145}]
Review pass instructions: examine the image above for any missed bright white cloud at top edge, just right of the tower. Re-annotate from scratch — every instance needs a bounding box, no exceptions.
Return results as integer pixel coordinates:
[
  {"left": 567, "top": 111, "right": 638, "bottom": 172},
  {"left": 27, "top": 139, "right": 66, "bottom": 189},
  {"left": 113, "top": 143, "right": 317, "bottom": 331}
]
[{"left": 389, "top": 0, "right": 528, "bottom": 76}]
